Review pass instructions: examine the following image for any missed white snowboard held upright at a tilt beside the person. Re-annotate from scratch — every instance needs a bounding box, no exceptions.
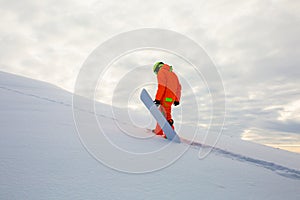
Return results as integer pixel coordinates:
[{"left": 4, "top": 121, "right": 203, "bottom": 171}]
[{"left": 140, "top": 89, "right": 180, "bottom": 143}]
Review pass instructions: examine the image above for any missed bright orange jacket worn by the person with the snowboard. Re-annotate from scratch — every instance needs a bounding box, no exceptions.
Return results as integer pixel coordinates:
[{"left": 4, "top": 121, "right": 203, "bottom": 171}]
[{"left": 155, "top": 64, "right": 181, "bottom": 104}]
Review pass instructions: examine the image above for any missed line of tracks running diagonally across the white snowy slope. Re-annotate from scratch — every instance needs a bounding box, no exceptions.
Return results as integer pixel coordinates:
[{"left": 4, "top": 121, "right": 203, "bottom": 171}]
[{"left": 0, "top": 86, "right": 300, "bottom": 180}]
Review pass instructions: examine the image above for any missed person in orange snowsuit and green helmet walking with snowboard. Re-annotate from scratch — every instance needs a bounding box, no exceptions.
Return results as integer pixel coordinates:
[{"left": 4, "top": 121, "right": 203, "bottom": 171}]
[{"left": 152, "top": 62, "right": 181, "bottom": 137}]
